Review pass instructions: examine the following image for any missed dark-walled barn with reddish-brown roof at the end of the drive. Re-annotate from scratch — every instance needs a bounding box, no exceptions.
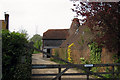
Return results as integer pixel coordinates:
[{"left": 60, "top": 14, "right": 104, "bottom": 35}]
[{"left": 42, "top": 29, "right": 69, "bottom": 58}]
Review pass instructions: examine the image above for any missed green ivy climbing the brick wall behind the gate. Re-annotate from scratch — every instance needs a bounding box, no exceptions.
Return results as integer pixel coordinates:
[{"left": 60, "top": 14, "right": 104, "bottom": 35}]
[{"left": 80, "top": 42, "right": 102, "bottom": 72}]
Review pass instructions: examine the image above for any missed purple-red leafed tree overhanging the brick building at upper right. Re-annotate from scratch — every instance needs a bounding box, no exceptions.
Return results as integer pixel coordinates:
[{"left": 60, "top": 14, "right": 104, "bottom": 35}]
[{"left": 72, "top": 2, "right": 120, "bottom": 50}]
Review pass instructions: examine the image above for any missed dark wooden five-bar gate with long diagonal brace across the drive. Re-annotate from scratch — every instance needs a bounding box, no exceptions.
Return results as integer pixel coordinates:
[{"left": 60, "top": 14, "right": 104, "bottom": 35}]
[{"left": 25, "top": 45, "right": 120, "bottom": 80}]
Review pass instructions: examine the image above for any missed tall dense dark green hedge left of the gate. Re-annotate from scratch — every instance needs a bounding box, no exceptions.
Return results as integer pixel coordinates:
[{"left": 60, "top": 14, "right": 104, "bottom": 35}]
[{"left": 2, "top": 30, "right": 33, "bottom": 80}]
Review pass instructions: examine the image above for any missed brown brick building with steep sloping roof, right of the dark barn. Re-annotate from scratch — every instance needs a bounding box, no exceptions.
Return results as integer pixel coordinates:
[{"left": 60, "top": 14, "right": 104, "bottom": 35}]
[{"left": 52, "top": 19, "right": 117, "bottom": 64}]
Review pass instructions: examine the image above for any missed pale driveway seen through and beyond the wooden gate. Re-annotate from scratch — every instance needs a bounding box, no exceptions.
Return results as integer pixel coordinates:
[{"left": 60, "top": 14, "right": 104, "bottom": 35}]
[{"left": 32, "top": 54, "right": 86, "bottom": 80}]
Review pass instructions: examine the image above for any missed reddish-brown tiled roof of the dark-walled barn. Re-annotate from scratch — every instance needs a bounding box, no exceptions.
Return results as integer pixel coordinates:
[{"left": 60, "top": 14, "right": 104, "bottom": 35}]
[{"left": 43, "top": 29, "right": 69, "bottom": 40}]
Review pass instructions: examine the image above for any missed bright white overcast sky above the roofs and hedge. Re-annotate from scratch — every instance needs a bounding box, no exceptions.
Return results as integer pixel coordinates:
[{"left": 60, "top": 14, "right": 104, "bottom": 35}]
[{"left": 0, "top": 0, "right": 75, "bottom": 37}]
